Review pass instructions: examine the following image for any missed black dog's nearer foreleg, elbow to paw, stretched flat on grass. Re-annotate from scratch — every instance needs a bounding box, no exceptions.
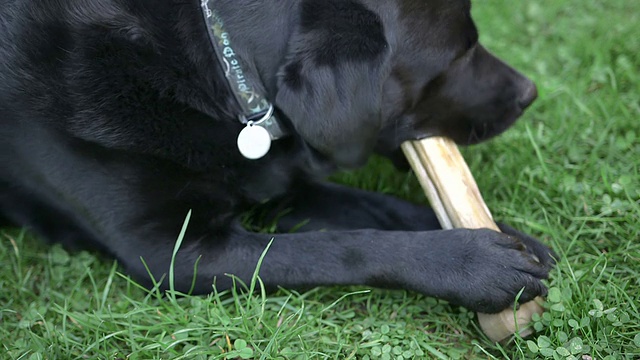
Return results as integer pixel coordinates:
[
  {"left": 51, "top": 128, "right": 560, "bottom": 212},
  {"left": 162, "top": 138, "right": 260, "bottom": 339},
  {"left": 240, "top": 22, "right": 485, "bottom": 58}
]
[{"left": 113, "top": 220, "right": 548, "bottom": 312}]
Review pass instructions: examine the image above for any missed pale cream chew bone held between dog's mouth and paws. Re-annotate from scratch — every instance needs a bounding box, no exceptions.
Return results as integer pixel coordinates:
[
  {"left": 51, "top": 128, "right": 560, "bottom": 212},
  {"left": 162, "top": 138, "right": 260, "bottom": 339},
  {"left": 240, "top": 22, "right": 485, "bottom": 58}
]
[{"left": 402, "top": 137, "right": 543, "bottom": 341}]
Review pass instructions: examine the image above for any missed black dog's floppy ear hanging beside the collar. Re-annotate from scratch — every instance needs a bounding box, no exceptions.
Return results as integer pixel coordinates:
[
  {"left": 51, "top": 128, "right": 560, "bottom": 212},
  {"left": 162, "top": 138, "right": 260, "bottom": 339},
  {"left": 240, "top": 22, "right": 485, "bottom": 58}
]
[{"left": 276, "top": 0, "right": 390, "bottom": 167}]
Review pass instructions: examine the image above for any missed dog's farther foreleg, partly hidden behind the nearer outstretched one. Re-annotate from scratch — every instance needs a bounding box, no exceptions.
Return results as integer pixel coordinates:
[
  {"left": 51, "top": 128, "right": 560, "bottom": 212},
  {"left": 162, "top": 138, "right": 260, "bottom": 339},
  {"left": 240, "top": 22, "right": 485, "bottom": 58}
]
[{"left": 260, "top": 183, "right": 440, "bottom": 231}]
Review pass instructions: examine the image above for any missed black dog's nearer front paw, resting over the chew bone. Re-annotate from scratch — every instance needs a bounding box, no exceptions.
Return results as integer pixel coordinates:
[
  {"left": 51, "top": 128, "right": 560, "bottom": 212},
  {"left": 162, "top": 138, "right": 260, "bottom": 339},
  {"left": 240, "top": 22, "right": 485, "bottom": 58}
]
[{"left": 430, "top": 229, "right": 552, "bottom": 313}]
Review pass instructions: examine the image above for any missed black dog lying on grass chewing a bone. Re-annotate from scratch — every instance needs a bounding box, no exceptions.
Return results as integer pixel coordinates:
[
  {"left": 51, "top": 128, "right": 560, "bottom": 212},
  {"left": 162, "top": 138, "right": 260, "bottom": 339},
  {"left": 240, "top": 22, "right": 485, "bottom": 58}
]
[{"left": 0, "top": 0, "right": 552, "bottom": 312}]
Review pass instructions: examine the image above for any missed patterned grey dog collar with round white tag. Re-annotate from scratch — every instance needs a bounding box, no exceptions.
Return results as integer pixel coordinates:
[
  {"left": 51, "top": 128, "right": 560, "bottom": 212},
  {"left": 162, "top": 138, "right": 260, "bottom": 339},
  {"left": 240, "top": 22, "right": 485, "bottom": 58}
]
[{"left": 200, "top": 0, "right": 287, "bottom": 160}]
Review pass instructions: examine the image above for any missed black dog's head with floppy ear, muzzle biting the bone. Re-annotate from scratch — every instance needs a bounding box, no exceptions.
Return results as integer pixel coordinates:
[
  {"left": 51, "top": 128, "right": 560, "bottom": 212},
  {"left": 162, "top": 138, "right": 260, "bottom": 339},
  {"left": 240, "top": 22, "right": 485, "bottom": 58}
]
[{"left": 276, "top": 0, "right": 536, "bottom": 167}]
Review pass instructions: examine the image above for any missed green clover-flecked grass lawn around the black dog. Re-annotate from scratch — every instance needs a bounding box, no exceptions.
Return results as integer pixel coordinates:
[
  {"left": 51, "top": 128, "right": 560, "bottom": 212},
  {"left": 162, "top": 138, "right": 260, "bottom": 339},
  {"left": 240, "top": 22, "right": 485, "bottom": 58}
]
[{"left": 0, "top": 0, "right": 640, "bottom": 359}]
